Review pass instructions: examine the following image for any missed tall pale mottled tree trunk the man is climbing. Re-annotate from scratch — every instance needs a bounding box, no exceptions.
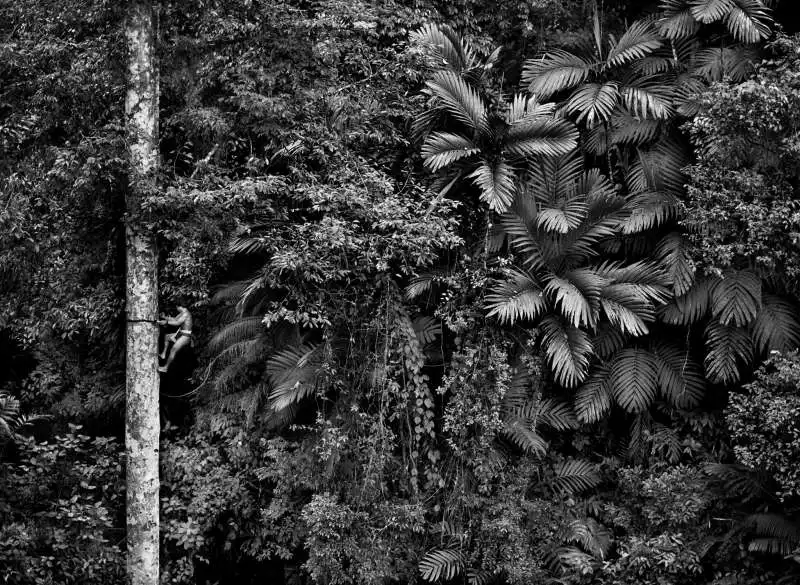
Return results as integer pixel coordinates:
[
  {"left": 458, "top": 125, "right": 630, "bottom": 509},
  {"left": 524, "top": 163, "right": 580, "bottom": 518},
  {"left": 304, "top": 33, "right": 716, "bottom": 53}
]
[{"left": 125, "top": 0, "right": 160, "bottom": 585}]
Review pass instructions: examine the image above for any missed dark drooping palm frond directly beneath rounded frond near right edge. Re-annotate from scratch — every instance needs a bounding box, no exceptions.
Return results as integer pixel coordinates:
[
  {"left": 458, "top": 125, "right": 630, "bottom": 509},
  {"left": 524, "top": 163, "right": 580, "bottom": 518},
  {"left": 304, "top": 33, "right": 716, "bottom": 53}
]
[{"left": 705, "top": 321, "right": 753, "bottom": 384}]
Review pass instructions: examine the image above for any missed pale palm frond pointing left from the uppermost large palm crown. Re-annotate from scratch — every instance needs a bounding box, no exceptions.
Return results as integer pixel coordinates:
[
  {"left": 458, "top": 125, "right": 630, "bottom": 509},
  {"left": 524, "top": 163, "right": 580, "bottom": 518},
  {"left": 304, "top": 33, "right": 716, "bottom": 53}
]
[{"left": 522, "top": 50, "right": 592, "bottom": 100}]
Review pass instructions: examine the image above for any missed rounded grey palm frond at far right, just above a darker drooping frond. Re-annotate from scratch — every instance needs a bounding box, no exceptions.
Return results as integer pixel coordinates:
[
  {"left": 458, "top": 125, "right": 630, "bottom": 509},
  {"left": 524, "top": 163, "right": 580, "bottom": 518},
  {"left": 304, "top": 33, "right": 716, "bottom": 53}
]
[{"left": 710, "top": 270, "right": 761, "bottom": 327}]
